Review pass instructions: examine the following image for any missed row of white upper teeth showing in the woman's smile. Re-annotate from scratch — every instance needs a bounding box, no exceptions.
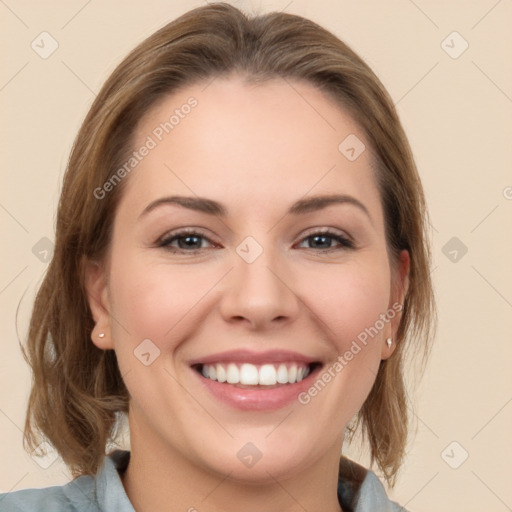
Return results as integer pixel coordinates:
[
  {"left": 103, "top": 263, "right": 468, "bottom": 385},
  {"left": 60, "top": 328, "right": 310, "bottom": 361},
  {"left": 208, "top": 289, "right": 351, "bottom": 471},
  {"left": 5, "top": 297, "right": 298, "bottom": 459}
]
[{"left": 201, "top": 363, "right": 310, "bottom": 386}]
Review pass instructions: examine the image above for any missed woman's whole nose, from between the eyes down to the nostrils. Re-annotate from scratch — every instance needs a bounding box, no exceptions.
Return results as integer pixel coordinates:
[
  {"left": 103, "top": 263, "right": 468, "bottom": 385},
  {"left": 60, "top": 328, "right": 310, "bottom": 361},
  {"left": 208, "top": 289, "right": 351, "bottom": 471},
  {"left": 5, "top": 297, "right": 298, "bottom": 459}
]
[{"left": 221, "top": 237, "right": 298, "bottom": 327}]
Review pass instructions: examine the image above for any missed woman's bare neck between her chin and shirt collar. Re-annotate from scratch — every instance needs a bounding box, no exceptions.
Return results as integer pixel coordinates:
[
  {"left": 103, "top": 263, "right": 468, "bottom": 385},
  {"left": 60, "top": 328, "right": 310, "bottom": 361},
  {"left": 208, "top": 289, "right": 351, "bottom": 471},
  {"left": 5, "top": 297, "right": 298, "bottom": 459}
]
[{"left": 122, "top": 414, "right": 342, "bottom": 512}]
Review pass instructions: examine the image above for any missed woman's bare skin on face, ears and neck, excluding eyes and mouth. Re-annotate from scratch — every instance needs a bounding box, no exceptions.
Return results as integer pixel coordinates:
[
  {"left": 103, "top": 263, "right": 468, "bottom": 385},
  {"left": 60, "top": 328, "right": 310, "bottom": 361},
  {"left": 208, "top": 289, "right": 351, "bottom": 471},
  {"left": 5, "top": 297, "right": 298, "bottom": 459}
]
[{"left": 87, "top": 75, "right": 409, "bottom": 512}]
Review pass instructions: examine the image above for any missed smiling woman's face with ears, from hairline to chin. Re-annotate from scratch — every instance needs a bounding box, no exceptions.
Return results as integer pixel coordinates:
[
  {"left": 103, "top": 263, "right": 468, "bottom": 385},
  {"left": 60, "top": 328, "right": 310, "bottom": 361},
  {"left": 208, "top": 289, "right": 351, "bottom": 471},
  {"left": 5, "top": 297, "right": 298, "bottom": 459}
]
[{"left": 88, "top": 77, "right": 408, "bottom": 480}]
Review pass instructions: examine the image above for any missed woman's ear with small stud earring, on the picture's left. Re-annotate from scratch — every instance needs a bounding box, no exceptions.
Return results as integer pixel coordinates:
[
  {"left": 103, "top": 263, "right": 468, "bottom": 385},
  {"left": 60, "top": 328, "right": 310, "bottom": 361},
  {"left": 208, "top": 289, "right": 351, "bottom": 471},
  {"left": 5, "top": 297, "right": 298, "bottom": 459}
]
[{"left": 84, "top": 260, "right": 114, "bottom": 350}]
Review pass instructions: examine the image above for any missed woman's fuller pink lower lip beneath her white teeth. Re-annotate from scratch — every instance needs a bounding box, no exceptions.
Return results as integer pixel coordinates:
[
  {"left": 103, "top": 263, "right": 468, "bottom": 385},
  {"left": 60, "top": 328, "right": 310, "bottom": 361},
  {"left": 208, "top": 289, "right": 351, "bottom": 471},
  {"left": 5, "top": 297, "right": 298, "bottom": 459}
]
[{"left": 192, "top": 368, "right": 319, "bottom": 411}]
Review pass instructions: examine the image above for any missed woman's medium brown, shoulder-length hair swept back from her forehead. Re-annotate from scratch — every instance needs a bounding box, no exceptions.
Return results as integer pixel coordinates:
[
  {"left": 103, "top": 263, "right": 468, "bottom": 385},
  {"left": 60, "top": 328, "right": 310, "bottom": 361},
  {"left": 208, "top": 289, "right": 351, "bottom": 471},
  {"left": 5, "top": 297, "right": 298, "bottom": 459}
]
[{"left": 25, "top": 3, "right": 435, "bottom": 485}]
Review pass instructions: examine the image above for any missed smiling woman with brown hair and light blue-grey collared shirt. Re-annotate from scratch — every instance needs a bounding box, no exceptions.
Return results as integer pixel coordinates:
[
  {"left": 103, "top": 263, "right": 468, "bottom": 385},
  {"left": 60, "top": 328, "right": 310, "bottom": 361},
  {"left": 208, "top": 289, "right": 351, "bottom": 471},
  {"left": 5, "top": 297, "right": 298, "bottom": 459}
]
[{"left": 0, "top": 4, "right": 434, "bottom": 512}]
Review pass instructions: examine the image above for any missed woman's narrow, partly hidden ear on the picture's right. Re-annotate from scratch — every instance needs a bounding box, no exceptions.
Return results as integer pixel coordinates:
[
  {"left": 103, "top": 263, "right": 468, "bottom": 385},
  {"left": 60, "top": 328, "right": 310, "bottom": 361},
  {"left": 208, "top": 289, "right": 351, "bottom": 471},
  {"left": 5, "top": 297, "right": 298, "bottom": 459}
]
[{"left": 381, "top": 249, "right": 410, "bottom": 359}]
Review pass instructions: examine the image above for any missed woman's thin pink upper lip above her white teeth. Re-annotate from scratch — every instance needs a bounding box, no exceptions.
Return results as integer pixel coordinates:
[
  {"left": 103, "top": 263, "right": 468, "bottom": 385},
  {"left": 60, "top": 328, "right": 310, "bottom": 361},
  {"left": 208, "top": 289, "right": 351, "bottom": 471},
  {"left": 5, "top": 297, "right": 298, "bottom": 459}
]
[{"left": 189, "top": 349, "right": 319, "bottom": 366}]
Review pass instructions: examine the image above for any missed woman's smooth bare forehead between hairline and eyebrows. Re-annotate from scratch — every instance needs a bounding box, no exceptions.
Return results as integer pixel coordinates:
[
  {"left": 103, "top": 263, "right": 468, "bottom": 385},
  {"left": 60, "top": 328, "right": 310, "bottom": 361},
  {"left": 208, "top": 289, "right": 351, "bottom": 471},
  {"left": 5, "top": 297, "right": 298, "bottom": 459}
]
[{"left": 121, "top": 73, "right": 380, "bottom": 224}]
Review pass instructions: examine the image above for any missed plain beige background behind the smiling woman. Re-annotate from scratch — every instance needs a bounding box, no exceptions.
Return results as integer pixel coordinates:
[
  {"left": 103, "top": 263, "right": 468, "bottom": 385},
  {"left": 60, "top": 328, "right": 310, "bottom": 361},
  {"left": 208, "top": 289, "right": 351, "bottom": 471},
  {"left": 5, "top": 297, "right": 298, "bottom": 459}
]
[{"left": 0, "top": 0, "right": 512, "bottom": 512}]
